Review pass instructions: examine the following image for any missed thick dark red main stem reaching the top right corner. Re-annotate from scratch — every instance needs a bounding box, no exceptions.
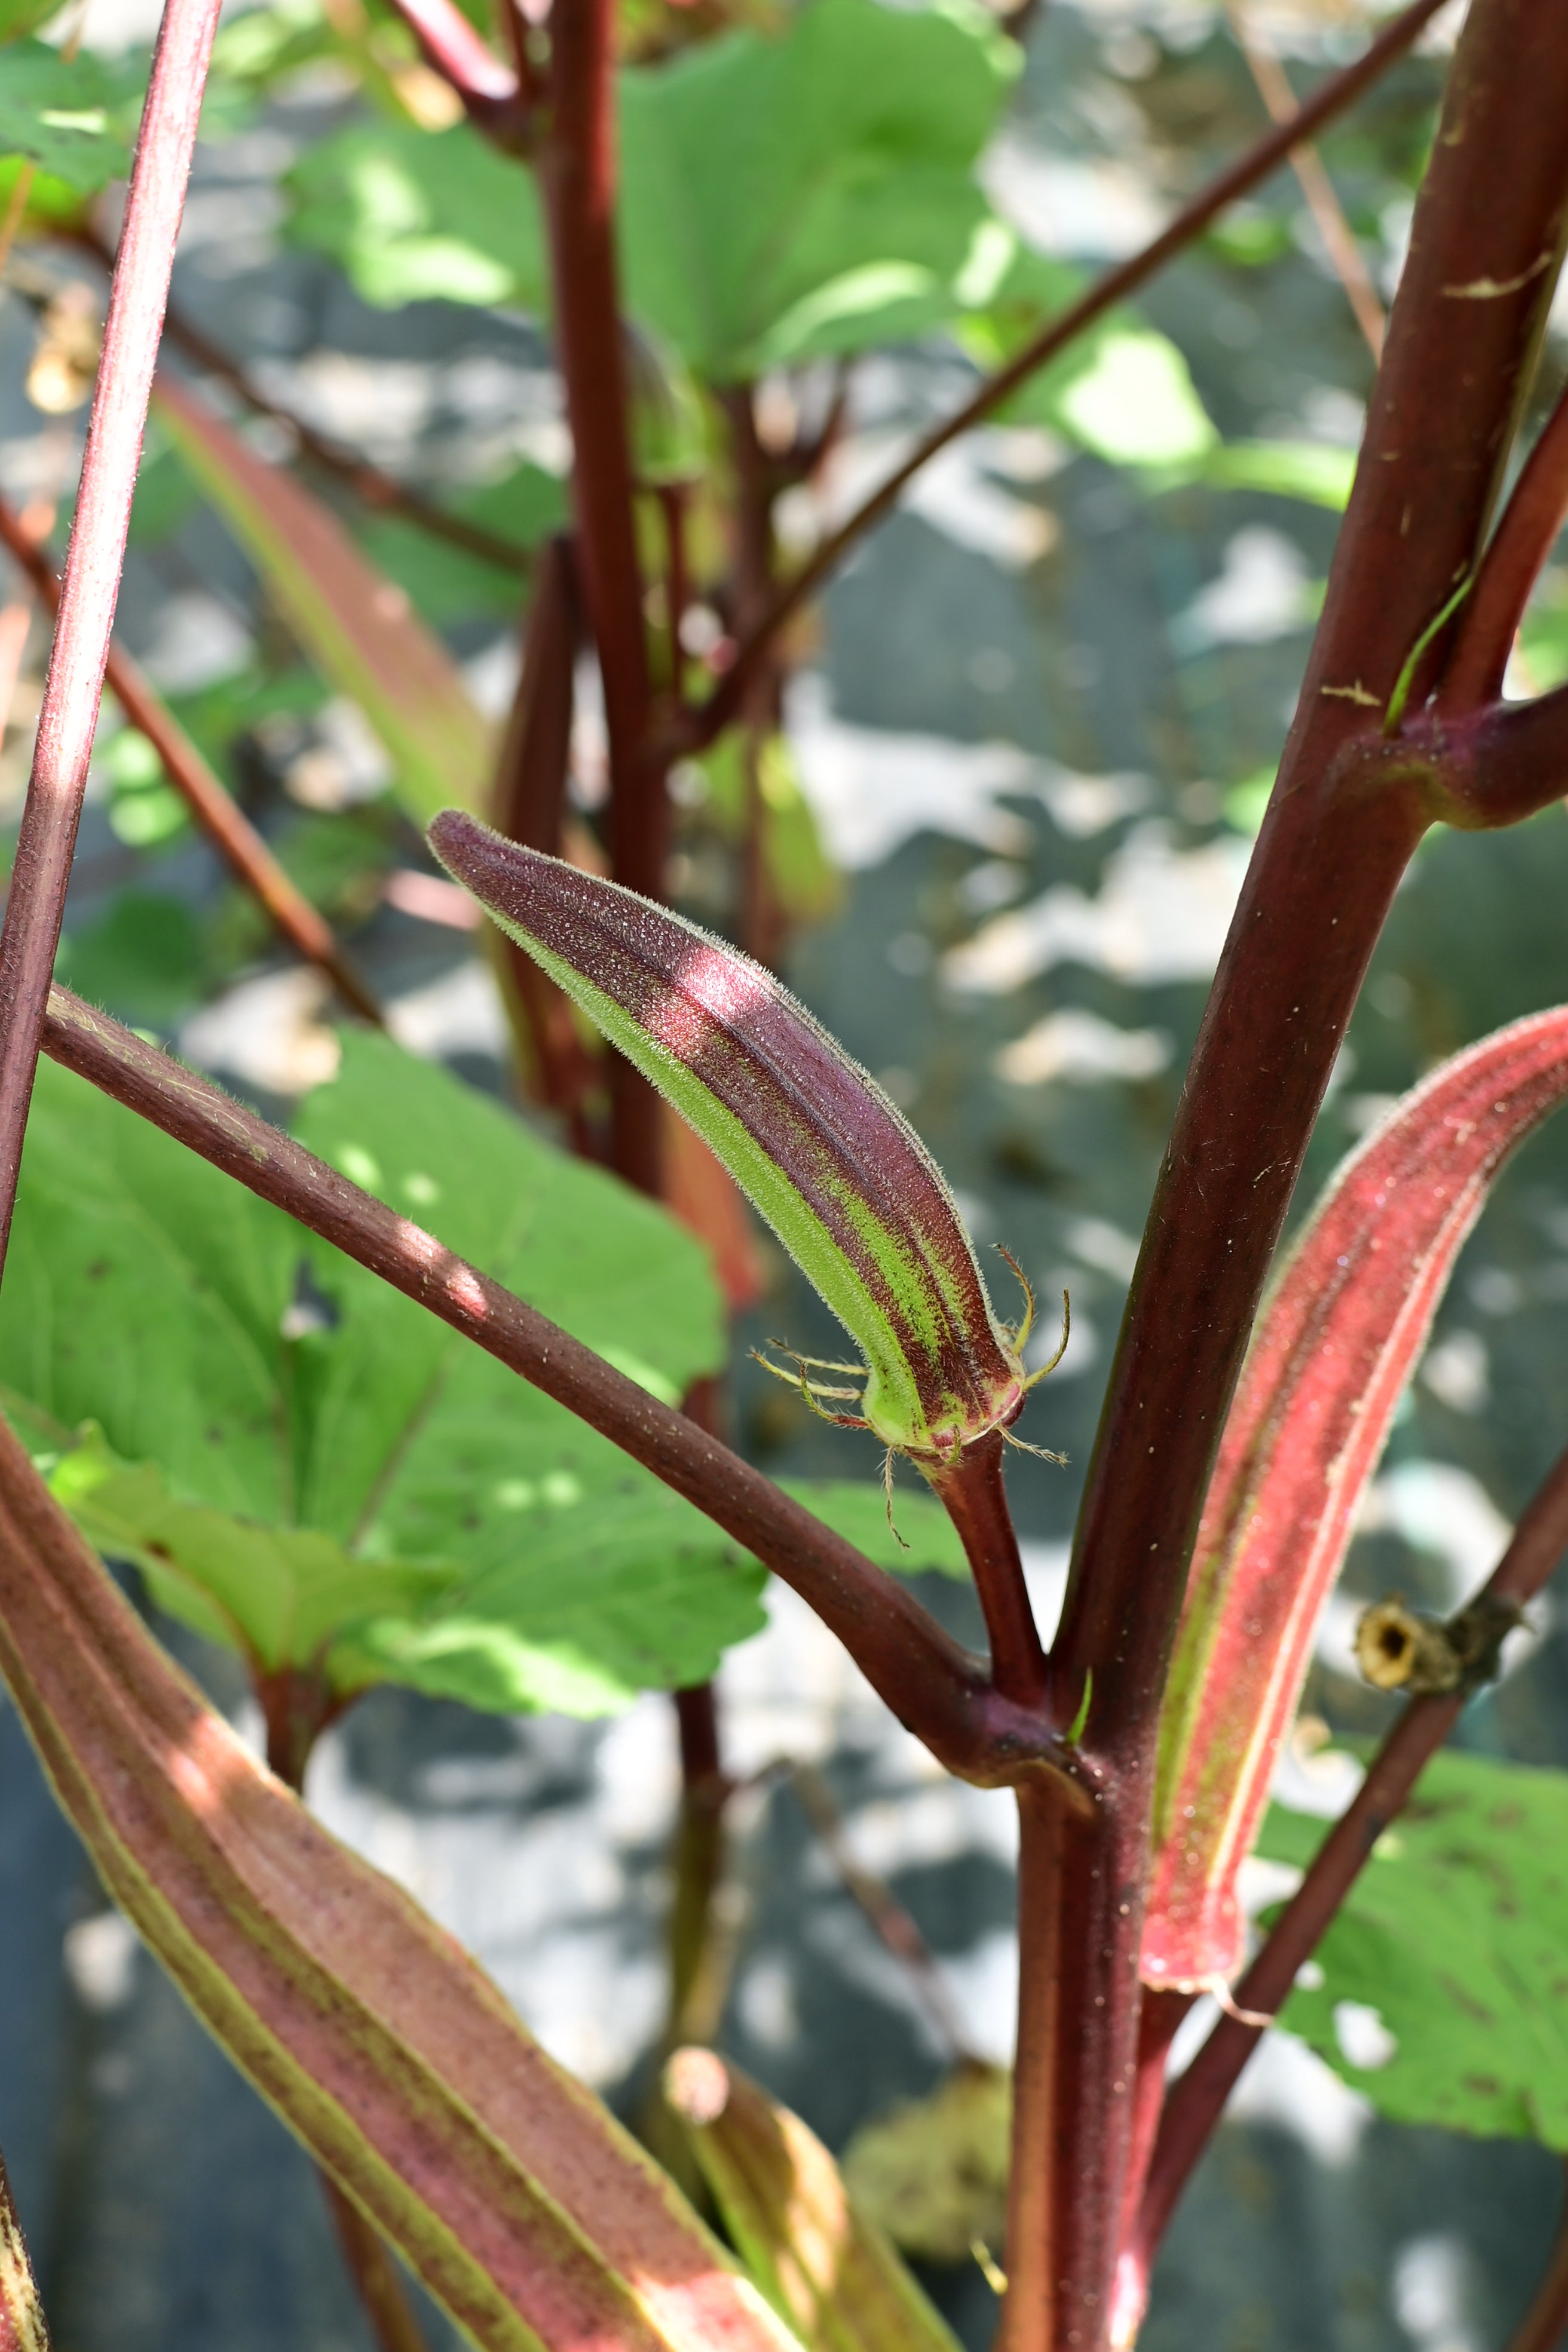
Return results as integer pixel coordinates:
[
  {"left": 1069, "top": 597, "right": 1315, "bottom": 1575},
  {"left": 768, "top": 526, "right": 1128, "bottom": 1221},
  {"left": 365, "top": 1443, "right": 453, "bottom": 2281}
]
[{"left": 1025, "top": 0, "right": 1568, "bottom": 2352}]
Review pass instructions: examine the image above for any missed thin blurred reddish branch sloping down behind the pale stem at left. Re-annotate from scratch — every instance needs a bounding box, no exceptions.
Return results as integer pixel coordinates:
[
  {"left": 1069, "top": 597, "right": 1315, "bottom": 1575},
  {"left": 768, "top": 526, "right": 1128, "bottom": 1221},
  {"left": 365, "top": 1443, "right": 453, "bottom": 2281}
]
[{"left": 0, "top": 498, "right": 383, "bottom": 1023}]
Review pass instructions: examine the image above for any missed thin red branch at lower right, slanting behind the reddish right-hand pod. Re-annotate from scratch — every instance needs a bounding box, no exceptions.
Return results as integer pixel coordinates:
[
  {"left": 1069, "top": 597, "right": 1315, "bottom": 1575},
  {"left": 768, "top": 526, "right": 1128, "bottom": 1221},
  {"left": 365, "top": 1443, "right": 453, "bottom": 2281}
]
[{"left": 1131, "top": 1451, "right": 1568, "bottom": 2279}]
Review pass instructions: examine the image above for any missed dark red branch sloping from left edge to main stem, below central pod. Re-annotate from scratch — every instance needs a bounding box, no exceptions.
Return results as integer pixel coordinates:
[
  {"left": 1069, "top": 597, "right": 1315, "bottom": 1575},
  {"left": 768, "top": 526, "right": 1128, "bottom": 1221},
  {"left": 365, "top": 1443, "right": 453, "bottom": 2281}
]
[{"left": 45, "top": 988, "right": 1053, "bottom": 1785}]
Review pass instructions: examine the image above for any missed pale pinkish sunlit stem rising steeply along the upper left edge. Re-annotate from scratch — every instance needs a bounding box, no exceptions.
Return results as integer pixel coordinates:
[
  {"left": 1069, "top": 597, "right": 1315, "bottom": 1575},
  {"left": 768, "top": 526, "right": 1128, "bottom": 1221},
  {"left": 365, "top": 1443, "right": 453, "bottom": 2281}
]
[{"left": 0, "top": 0, "right": 219, "bottom": 1288}]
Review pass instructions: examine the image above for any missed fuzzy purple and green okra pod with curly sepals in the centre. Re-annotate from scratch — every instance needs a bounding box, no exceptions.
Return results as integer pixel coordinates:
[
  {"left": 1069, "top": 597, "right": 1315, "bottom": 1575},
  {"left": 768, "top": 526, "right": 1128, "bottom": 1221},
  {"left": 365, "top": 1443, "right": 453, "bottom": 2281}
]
[{"left": 430, "top": 809, "right": 1053, "bottom": 1470}]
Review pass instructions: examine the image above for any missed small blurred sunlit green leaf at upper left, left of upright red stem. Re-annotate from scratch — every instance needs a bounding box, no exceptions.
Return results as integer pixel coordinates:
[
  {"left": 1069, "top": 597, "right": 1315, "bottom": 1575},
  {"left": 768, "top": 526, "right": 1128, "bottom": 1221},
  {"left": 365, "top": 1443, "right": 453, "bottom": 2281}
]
[{"left": 284, "top": 122, "right": 548, "bottom": 313}]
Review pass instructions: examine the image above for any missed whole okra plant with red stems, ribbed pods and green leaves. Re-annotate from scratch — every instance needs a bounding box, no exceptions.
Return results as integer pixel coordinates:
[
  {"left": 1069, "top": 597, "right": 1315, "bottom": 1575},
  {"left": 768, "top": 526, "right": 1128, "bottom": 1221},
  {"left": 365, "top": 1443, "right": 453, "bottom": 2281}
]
[{"left": 0, "top": 0, "right": 1568, "bottom": 2352}]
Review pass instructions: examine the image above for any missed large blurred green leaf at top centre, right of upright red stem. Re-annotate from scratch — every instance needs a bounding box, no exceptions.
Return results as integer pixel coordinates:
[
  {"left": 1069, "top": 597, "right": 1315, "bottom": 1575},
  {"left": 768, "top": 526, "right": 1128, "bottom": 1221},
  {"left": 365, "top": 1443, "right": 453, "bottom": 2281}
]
[{"left": 621, "top": 0, "right": 1018, "bottom": 381}]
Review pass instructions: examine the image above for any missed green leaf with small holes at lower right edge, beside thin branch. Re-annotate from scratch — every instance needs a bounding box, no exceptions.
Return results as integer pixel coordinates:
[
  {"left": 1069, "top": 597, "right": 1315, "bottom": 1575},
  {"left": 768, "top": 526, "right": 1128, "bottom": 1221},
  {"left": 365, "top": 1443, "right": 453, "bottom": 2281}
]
[{"left": 1258, "top": 1754, "right": 1568, "bottom": 2150}]
